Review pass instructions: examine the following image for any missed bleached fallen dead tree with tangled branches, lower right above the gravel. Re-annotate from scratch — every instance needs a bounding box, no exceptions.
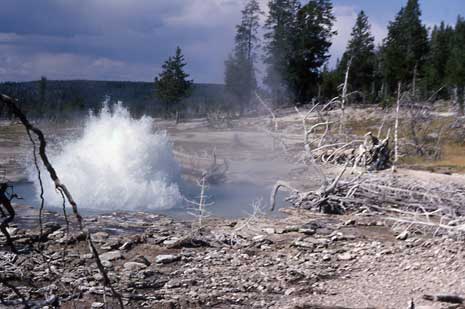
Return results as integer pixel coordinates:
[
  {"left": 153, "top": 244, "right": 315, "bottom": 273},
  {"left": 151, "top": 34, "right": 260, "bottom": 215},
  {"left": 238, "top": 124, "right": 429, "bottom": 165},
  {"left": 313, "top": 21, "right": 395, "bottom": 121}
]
[{"left": 270, "top": 168, "right": 465, "bottom": 239}]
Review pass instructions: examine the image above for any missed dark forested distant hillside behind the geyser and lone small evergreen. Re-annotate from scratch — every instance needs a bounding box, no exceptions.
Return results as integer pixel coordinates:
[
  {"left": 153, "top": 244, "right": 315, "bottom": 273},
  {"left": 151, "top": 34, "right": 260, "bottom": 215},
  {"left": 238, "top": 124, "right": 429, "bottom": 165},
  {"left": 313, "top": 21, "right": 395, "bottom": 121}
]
[{"left": 0, "top": 80, "right": 224, "bottom": 116}]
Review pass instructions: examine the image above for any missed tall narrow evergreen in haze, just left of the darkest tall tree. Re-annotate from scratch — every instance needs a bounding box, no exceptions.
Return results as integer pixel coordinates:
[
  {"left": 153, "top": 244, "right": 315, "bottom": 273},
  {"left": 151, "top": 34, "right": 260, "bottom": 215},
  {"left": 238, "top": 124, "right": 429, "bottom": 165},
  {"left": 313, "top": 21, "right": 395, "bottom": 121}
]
[{"left": 264, "top": 0, "right": 300, "bottom": 104}]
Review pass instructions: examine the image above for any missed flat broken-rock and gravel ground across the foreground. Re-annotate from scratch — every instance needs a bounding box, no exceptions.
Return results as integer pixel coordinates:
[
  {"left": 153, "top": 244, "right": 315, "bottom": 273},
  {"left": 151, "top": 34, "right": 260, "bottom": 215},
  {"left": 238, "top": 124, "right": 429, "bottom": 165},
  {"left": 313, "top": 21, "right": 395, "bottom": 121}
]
[{"left": 0, "top": 203, "right": 465, "bottom": 308}]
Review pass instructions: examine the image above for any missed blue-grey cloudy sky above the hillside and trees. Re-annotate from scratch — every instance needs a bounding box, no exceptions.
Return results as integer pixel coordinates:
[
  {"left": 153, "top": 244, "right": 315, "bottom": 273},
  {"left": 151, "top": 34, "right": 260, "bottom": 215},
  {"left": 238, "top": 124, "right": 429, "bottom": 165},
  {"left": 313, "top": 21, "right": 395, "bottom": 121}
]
[{"left": 0, "top": 0, "right": 465, "bottom": 83}]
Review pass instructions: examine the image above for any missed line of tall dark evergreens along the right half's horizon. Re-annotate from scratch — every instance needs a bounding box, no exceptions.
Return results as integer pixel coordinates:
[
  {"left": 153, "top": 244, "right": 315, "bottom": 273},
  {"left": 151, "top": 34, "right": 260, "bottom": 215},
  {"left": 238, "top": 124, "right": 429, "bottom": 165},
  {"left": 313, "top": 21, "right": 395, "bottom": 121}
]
[{"left": 225, "top": 0, "right": 465, "bottom": 110}]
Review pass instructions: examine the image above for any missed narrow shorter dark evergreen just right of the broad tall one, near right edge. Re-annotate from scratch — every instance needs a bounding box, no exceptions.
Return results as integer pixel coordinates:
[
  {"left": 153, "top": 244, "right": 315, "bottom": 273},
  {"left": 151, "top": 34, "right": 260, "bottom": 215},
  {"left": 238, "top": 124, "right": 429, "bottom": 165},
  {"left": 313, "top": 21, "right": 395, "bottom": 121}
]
[{"left": 426, "top": 22, "right": 454, "bottom": 91}]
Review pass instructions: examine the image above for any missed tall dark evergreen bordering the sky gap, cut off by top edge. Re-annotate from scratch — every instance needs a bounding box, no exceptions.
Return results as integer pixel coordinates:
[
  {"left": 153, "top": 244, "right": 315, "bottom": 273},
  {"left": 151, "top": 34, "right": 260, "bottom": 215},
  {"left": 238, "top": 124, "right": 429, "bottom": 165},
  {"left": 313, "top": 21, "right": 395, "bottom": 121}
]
[{"left": 287, "top": 0, "right": 336, "bottom": 103}]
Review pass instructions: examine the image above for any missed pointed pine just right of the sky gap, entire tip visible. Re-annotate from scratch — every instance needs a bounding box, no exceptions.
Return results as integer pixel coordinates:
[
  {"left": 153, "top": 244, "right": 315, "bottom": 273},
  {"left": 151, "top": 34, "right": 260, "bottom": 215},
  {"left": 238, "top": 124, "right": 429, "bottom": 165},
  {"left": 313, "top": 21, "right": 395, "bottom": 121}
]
[{"left": 338, "top": 11, "right": 376, "bottom": 100}]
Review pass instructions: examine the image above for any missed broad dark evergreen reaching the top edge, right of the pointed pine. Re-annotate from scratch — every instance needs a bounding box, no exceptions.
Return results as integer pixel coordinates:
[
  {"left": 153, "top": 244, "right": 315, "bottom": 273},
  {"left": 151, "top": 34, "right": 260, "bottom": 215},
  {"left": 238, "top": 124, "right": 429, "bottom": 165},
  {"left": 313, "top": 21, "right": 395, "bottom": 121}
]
[{"left": 383, "top": 0, "right": 428, "bottom": 92}]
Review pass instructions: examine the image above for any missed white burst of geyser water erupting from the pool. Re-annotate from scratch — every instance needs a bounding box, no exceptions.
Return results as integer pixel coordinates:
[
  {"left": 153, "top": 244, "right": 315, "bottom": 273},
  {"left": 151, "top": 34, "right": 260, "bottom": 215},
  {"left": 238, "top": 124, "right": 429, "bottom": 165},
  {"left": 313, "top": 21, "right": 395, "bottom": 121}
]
[{"left": 34, "top": 103, "right": 181, "bottom": 210}]
